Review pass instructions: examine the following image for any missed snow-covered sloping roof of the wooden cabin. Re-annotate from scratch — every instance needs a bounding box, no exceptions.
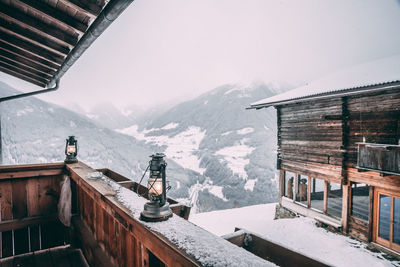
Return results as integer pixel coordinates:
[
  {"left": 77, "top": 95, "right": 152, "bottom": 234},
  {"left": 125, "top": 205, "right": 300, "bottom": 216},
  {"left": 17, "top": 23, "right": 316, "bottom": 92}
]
[{"left": 250, "top": 54, "right": 400, "bottom": 108}]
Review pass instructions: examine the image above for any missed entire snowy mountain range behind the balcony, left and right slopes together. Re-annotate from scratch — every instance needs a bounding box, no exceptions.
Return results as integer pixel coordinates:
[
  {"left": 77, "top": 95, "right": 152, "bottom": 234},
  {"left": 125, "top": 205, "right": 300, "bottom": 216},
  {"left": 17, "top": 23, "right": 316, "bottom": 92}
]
[{"left": 0, "top": 83, "right": 288, "bottom": 212}]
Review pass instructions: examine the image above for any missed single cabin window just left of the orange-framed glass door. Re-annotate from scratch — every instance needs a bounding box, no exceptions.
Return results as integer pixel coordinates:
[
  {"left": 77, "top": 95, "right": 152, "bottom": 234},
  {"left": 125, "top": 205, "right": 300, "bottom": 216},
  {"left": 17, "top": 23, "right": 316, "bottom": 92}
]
[{"left": 351, "top": 183, "right": 369, "bottom": 222}]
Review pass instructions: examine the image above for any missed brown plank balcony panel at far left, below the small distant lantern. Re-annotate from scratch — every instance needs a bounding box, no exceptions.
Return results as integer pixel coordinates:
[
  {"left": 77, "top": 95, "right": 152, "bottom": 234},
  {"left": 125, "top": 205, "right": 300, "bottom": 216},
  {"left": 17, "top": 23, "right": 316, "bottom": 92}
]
[{"left": 0, "top": 164, "right": 67, "bottom": 258}]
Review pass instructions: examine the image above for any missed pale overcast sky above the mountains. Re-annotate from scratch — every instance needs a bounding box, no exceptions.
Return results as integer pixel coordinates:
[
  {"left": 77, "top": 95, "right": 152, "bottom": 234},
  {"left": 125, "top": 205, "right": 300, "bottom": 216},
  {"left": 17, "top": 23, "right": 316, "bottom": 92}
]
[{"left": 0, "top": 0, "right": 400, "bottom": 111}]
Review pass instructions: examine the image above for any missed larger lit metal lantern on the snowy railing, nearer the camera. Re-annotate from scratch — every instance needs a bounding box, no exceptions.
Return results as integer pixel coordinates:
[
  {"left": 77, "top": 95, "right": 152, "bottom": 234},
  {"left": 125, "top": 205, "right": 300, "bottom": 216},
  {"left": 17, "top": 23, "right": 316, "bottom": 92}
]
[{"left": 140, "top": 153, "right": 172, "bottom": 222}]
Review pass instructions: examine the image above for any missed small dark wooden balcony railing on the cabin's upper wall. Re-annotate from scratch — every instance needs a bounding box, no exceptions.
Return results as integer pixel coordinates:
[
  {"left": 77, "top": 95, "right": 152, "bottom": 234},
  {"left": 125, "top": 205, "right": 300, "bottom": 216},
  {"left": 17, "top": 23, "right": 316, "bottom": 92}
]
[{"left": 357, "top": 143, "right": 400, "bottom": 175}]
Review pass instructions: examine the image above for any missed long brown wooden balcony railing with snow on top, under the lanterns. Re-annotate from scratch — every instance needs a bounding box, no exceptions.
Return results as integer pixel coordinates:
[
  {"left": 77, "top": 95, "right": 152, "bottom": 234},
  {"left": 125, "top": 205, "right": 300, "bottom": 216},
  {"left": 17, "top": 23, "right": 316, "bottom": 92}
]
[{"left": 0, "top": 162, "right": 271, "bottom": 266}]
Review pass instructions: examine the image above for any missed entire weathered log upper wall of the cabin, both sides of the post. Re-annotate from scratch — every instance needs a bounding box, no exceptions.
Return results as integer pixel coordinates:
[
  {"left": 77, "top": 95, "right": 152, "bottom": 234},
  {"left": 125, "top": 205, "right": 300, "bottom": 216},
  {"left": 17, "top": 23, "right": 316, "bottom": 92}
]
[{"left": 277, "top": 87, "right": 400, "bottom": 181}]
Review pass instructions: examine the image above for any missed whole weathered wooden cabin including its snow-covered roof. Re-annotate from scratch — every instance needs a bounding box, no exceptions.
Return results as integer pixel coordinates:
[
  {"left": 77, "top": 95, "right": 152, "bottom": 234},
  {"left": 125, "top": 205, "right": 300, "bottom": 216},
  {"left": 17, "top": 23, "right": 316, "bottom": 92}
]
[{"left": 250, "top": 56, "right": 400, "bottom": 253}]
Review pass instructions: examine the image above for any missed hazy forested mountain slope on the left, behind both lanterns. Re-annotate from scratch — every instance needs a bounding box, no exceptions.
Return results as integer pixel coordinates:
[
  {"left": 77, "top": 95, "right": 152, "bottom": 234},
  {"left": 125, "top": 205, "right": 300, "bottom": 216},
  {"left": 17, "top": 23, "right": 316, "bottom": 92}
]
[{"left": 0, "top": 82, "right": 197, "bottom": 197}]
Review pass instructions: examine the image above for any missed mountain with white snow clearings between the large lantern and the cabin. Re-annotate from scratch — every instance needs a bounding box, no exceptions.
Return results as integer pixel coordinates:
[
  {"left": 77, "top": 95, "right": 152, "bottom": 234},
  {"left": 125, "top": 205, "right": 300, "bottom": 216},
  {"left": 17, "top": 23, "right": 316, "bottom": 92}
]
[{"left": 118, "top": 84, "right": 286, "bottom": 212}]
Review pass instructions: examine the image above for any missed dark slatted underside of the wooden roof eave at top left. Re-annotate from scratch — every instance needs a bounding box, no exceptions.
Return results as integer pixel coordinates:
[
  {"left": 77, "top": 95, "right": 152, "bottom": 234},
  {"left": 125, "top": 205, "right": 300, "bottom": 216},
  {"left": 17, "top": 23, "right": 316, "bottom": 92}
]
[{"left": 0, "top": 0, "right": 133, "bottom": 88}]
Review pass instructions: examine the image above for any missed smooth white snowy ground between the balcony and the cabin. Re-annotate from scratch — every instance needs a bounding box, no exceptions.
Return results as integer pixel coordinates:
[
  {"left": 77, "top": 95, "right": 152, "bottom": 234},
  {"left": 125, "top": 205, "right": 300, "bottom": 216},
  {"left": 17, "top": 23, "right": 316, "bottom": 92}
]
[{"left": 189, "top": 203, "right": 399, "bottom": 266}]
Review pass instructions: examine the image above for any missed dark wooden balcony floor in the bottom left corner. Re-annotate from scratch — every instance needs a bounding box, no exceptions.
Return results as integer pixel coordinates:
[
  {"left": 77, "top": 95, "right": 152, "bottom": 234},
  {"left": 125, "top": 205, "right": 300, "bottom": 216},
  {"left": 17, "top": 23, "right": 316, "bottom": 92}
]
[{"left": 0, "top": 246, "right": 89, "bottom": 267}]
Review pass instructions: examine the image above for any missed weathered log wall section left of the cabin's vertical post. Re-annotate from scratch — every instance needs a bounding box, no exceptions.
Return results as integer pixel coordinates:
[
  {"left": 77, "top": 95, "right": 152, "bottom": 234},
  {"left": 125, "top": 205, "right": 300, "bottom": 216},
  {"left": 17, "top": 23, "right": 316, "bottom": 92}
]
[{"left": 278, "top": 98, "right": 343, "bottom": 182}]
